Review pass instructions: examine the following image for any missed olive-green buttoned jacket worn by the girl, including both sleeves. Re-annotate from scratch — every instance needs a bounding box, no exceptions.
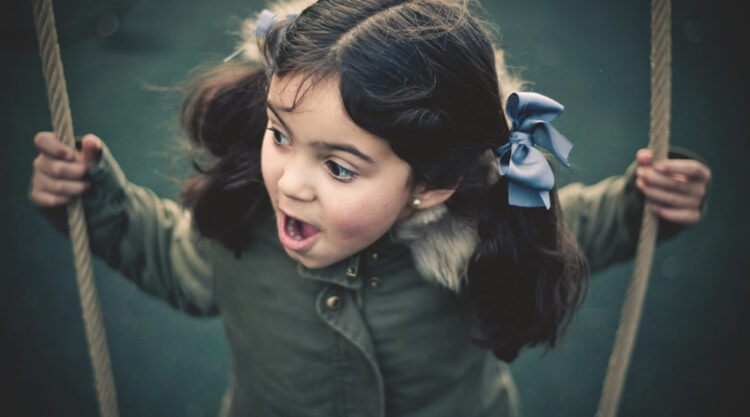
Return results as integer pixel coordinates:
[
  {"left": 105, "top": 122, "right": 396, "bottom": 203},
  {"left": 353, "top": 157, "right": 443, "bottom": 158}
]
[{"left": 39, "top": 146, "right": 704, "bottom": 417}]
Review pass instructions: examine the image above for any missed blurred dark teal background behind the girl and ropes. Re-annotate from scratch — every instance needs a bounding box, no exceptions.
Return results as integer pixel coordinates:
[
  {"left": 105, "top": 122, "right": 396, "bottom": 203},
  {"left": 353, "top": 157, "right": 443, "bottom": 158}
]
[{"left": 0, "top": 0, "right": 750, "bottom": 417}]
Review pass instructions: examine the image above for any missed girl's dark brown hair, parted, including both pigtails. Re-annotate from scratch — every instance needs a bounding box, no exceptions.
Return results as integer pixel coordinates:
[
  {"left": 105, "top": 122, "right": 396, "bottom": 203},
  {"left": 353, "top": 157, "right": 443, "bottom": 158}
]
[{"left": 181, "top": 0, "right": 588, "bottom": 361}]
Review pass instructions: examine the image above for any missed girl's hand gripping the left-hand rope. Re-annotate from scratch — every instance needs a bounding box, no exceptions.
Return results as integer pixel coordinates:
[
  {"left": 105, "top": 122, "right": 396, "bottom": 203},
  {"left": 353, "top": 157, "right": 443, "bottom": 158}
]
[{"left": 29, "top": 132, "right": 102, "bottom": 207}]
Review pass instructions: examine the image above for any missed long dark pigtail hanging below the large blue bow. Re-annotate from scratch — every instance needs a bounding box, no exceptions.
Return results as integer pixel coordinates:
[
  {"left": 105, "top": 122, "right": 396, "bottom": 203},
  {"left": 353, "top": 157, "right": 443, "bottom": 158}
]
[{"left": 462, "top": 154, "right": 589, "bottom": 362}]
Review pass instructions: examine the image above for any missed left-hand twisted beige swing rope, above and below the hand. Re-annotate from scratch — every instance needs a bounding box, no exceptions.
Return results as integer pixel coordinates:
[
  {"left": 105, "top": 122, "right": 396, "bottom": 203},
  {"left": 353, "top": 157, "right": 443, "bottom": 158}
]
[{"left": 33, "top": 0, "right": 119, "bottom": 417}]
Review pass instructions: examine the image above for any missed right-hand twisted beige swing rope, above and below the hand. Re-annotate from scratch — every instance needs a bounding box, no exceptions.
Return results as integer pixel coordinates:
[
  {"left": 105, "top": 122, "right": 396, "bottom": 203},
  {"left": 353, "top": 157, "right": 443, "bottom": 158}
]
[{"left": 596, "top": 0, "right": 672, "bottom": 417}]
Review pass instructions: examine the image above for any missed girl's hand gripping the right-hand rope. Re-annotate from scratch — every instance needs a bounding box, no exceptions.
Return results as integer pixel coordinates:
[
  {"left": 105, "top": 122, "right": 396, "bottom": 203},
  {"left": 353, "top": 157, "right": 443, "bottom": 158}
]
[{"left": 635, "top": 148, "right": 711, "bottom": 225}]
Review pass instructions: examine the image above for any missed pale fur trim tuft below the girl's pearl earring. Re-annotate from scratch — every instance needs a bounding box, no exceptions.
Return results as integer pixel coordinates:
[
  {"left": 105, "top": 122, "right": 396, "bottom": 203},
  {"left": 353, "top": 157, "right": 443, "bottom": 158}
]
[{"left": 395, "top": 204, "right": 479, "bottom": 292}]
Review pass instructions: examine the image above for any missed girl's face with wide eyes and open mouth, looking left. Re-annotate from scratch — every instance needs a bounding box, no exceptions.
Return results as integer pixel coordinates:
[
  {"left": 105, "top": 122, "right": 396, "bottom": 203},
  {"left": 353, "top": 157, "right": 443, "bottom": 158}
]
[{"left": 261, "top": 75, "right": 413, "bottom": 268}]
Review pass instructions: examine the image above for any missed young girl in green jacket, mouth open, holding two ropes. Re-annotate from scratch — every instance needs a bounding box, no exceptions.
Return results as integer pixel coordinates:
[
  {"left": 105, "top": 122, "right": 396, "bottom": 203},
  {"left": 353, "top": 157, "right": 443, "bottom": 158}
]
[{"left": 30, "top": 0, "right": 710, "bottom": 416}]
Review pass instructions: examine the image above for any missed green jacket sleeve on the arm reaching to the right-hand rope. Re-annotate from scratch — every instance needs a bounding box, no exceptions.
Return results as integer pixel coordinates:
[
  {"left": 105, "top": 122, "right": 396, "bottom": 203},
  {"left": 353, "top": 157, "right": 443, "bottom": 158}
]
[{"left": 558, "top": 146, "right": 710, "bottom": 272}]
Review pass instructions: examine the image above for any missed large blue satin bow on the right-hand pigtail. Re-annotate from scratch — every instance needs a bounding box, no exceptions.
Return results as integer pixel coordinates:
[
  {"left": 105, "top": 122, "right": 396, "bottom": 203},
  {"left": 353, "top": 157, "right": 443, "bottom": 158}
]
[{"left": 497, "top": 93, "right": 573, "bottom": 210}]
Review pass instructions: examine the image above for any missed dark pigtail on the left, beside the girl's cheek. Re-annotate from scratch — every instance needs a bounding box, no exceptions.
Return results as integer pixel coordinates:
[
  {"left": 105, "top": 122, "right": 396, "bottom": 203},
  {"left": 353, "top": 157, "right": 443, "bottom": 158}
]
[{"left": 178, "top": 62, "right": 270, "bottom": 257}]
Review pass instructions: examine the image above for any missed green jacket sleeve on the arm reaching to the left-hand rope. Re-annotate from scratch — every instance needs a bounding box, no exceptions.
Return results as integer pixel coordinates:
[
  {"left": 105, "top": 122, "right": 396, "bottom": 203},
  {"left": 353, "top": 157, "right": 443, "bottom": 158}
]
[{"left": 35, "top": 141, "right": 218, "bottom": 315}]
